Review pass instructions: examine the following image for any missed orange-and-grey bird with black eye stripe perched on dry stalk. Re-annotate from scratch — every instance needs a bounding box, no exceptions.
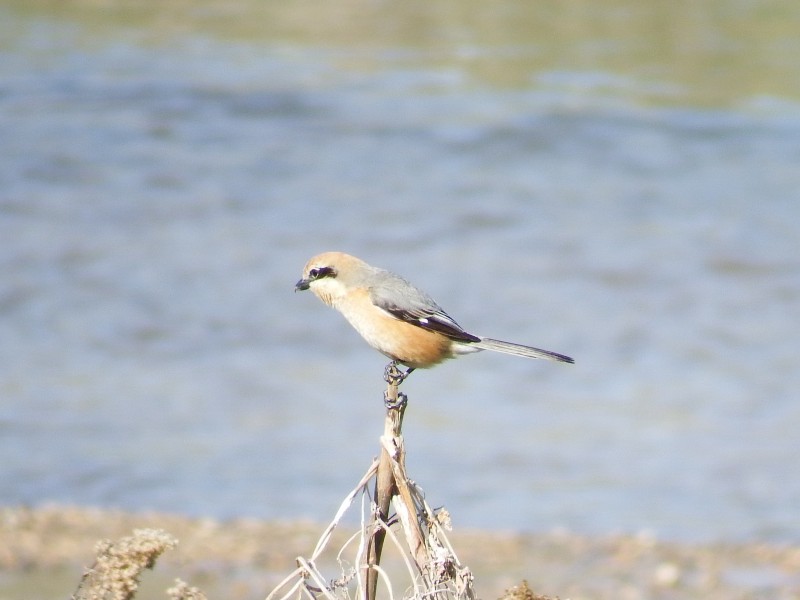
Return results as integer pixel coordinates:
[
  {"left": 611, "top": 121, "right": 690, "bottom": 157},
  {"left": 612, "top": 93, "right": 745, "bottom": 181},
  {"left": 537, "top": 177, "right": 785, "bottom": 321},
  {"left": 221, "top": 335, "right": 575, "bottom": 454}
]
[{"left": 295, "top": 252, "right": 575, "bottom": 375}]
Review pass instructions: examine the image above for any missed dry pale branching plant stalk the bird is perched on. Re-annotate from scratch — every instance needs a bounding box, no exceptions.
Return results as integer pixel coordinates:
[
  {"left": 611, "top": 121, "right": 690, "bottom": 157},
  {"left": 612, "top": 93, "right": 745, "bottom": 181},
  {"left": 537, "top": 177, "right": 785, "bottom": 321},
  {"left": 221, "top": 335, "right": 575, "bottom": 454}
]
[{"left": 267, "top": 363, "right": 475, "bottom": 600}]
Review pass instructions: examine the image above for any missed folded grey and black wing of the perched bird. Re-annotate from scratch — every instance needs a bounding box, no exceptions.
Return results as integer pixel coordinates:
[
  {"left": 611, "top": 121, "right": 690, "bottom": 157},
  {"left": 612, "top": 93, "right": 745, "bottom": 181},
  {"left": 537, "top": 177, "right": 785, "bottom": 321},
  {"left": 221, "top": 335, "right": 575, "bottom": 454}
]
[{"left": 370, "top": 276, "right": 481, "bottom": 342}]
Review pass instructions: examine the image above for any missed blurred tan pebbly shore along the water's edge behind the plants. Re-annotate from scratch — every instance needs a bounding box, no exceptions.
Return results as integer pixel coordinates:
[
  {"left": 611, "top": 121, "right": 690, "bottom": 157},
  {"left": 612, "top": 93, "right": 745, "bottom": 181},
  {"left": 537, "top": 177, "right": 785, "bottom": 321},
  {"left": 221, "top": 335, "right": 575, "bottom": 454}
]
[{"left": 0, "top": 506, "right": 800, "bottom": 600}]
